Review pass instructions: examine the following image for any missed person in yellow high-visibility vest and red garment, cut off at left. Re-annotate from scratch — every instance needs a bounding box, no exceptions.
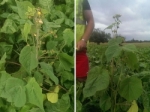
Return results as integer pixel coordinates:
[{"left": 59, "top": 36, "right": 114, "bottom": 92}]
[{"left": 76, "top": 0, "right": 94, "bottom": 82}]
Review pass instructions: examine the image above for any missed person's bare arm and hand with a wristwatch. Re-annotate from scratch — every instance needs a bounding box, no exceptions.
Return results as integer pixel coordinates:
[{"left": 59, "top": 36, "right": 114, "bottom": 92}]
[{"left": 77, "top": 10, "right": 94, "bottom": 50}]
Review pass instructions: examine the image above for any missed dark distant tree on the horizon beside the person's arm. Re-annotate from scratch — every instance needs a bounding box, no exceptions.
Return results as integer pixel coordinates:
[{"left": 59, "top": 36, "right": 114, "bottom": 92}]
[{"left": 89, "top": 28, "right": 111, "bottom": 44}]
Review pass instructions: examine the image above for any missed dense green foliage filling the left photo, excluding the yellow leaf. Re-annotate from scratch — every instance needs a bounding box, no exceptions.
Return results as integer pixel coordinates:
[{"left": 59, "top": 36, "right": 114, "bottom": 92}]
[{"left": 0, "top": 0, "right": 74, "bottom": 112}]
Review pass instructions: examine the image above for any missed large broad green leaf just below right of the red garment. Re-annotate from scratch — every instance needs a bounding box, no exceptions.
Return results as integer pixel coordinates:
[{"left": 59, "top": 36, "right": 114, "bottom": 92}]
[{"left": 83, "top": 66, "right": 109, "bottom": 98}]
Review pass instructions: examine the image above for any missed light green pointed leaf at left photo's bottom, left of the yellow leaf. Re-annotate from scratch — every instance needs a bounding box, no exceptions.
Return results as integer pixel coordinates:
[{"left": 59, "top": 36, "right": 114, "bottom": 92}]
[{"left": 26, "top": 78, "right": 44, "bottom": 112}]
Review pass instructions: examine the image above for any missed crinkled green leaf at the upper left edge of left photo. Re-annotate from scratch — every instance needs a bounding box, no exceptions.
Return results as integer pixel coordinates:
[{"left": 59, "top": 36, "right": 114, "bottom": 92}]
[{"left": 0, "top": 19, "right": 18, "bottom": 34}]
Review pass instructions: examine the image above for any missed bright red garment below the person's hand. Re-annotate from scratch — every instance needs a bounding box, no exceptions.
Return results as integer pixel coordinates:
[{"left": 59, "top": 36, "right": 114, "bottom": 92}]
[{"left": 76, "top": 49, "right": 89, "bottom": 78}]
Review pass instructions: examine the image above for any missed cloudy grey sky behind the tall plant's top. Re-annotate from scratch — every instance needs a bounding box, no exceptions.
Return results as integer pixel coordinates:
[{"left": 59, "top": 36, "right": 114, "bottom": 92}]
[{"left": 88, "top": 0, "right": 150, "bottom": 41}]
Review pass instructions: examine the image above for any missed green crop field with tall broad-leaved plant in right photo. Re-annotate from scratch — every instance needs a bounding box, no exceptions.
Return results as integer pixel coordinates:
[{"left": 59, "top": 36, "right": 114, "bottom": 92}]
[{"left": 77, "top": 38, "right": 150, "bottom": 112}]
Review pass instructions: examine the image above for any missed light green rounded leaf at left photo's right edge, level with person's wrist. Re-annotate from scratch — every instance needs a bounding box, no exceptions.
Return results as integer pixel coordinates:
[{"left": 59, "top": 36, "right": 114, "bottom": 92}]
[{"left": 63, "top": 29, "right": 74, "bottom": 46}]
